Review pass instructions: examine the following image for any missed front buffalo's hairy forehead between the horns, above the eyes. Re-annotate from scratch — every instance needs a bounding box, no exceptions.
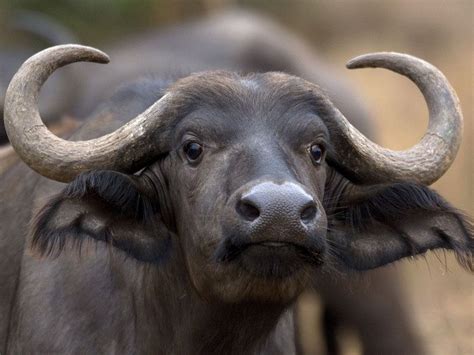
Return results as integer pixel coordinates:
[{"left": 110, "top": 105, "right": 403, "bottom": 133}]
[{"left": 172, "top": 73, "right": 327, "bottom": 141}]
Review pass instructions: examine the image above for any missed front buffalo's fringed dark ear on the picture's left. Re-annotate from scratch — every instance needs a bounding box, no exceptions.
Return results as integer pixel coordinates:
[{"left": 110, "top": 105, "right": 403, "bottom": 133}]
[{"left": 31, "top": 171, "right": 170, "bottom": 262}]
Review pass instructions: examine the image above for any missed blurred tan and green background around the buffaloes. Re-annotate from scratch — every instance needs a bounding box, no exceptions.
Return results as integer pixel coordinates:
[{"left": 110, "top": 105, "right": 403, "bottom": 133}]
[{"left": 0, "top": 0, "right": 474, "bottom": 355}]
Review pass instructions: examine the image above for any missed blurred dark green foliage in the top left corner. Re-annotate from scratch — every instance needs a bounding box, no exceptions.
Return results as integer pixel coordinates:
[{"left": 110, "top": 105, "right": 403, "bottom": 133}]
[{"left": 0, "top": 0, "right": 208, "bottom": 44}]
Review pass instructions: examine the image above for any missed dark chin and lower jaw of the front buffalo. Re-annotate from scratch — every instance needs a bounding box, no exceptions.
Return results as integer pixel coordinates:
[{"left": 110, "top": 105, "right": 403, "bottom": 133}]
[{"left": 190, "top": 252, "right": 317, "bottom": 304}]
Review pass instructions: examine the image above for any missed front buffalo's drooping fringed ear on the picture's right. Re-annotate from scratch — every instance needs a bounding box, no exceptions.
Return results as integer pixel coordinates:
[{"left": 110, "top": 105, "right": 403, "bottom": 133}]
[{"left": 328, "top": 183, "right": 474, "bottom": 271}]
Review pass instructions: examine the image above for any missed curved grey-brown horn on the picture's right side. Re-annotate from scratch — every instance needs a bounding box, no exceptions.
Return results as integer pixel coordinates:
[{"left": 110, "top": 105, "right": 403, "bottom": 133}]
[{"left": 324, "top": 52, "right": 463, "bottom": 185}]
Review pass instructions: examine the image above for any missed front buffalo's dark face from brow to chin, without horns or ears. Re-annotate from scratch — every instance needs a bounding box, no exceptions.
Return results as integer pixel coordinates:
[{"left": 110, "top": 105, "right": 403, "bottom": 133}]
[{"left": 161, "top": 74, "right": 328, "bottom": 302}]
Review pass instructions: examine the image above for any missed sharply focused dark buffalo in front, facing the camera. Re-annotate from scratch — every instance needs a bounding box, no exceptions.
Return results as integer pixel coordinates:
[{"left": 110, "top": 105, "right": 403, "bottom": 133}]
[{"left": 0, "top": 45, "right": 474, "bottom": 354}]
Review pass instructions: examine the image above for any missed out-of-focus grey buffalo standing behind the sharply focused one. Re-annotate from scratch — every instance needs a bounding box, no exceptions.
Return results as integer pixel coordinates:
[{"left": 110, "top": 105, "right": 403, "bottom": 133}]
[{"left": 65, "top": 10, "right": 423, "bottom": 354}]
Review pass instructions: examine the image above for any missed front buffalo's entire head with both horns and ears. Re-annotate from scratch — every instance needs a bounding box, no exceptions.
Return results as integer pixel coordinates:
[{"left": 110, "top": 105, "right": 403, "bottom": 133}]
[{"left": 6, "top": 45, "right": 473, "bottom": 302}]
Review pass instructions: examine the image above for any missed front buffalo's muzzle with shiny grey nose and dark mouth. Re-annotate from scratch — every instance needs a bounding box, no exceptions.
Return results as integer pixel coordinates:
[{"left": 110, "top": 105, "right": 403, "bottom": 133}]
[{"left": 224, "top": 182, "right": 326, "bottom": 278}]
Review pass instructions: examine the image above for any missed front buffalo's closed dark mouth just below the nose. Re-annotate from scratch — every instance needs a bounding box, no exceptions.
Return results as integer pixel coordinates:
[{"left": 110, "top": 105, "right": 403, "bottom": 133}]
[{"left": 216, "top": 238, "right": 324, "bottom": 279}]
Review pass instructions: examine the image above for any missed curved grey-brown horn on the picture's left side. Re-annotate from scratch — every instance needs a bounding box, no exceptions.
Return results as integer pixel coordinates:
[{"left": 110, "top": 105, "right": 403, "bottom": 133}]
[{"left": 4, "top": 44, "right": 176, "bottom": 182}]
